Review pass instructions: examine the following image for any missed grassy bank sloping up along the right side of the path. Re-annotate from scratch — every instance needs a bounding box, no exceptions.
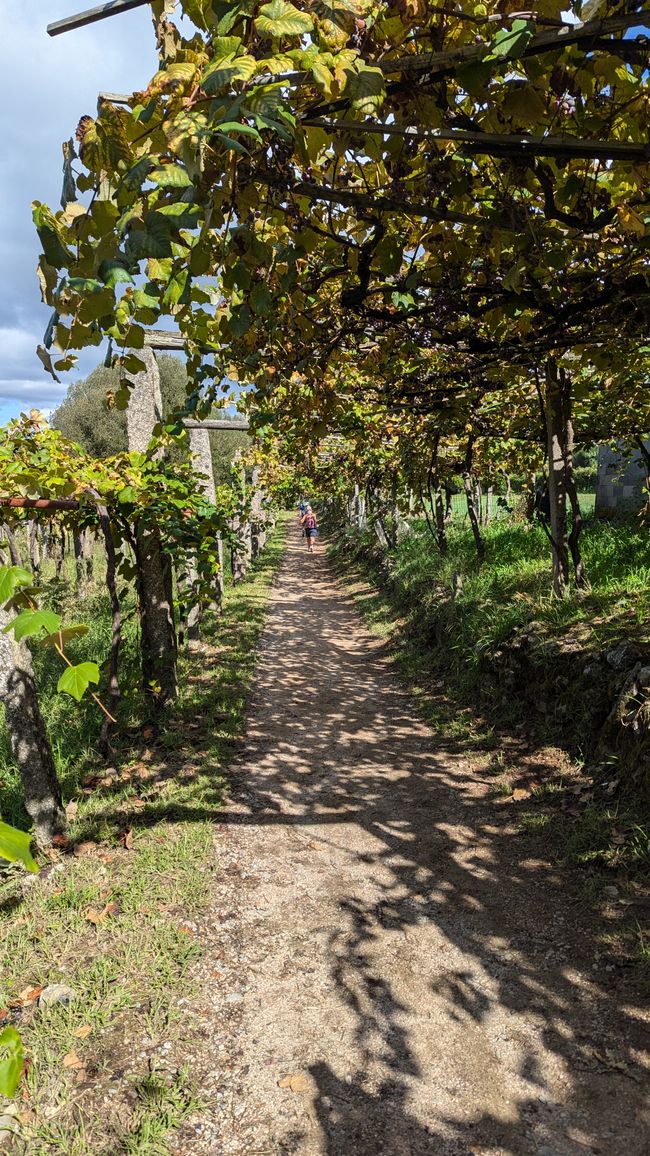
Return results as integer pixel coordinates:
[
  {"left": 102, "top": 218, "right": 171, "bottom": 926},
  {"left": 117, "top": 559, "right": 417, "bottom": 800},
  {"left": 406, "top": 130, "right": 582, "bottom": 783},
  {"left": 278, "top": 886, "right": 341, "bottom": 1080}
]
[{"left": 331, "top": 510, "right": 650, "bottom": 962}]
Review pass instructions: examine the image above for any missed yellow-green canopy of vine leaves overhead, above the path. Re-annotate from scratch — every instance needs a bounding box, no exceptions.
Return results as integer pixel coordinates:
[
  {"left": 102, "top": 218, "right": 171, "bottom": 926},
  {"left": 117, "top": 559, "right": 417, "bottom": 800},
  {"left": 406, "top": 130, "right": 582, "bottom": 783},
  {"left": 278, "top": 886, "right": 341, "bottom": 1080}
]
[{"left": 30, "top": 0, "right": 650, "bottom": 464}]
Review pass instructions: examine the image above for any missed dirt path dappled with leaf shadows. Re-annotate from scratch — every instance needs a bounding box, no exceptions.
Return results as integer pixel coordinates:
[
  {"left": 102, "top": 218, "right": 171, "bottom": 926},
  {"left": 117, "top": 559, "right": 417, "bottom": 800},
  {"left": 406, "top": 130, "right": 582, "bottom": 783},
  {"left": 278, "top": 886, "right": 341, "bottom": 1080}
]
[{"left": 175, "top": 529, "right": 649, "bottom": 1156}]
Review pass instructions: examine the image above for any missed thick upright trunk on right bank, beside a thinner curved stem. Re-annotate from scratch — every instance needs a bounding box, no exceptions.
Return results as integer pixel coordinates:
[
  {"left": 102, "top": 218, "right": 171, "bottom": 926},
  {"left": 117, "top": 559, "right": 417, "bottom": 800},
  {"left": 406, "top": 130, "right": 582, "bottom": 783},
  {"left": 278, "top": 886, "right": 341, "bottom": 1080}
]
[{"left": 545, "top": 357, "right": 569, "bottom": 598}]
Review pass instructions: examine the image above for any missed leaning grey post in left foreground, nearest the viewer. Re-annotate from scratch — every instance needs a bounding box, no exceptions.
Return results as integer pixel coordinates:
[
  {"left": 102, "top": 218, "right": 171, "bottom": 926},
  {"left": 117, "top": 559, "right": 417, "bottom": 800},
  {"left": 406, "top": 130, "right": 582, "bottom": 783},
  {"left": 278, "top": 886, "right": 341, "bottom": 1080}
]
[{"left": 0, "top": 607, "right": 66, "bottom": 847}]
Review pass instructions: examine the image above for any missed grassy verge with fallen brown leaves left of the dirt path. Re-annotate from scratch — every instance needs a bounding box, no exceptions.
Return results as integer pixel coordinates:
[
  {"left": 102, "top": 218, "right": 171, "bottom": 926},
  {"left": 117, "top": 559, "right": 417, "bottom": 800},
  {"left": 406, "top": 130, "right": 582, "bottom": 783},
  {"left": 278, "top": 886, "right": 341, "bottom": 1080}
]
[{"left": 0, "top": 523, "right": 285, "bottom": 1156}]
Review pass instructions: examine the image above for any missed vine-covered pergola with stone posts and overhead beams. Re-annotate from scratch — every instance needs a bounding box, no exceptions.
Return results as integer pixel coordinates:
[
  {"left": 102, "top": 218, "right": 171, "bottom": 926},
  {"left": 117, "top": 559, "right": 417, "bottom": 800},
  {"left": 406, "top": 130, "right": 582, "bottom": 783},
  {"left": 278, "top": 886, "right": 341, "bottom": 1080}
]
[{"left": 0, "top": 0, "right": 650, "bottom": 846}]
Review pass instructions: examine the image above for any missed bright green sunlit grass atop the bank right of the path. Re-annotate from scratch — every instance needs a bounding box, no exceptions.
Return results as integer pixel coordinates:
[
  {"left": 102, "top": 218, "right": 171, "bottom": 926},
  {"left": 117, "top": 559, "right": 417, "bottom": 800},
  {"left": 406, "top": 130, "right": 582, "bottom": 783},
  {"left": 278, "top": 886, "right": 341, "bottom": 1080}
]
[{"left": 333, "top": 519, "right": 650, "bottom": 712}]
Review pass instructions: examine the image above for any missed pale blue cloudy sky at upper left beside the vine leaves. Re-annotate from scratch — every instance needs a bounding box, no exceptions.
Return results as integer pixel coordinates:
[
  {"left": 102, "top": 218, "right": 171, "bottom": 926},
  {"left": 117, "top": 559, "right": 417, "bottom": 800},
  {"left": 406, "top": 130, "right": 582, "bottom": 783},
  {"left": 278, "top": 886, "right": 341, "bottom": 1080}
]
[{"left": 0, "top": 0, "right": 156, "bottom": 423}]
